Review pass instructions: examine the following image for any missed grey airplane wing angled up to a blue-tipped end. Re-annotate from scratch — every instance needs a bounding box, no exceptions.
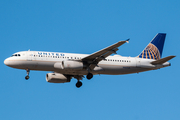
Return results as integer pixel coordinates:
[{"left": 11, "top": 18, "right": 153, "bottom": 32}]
[{"left": 82, "top": 39, "right": 129, "bottom": 70}]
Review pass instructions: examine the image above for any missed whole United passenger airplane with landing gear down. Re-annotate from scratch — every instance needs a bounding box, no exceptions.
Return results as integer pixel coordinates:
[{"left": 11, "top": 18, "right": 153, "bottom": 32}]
[{"left": 4, "top": 33, "right": 175, "bottom": 88}]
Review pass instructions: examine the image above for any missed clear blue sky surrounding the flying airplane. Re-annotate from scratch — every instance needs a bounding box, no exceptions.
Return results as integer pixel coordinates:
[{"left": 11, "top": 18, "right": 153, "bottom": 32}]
[{"left": 0, "top": 0, "right": 180, "bottom": 120}]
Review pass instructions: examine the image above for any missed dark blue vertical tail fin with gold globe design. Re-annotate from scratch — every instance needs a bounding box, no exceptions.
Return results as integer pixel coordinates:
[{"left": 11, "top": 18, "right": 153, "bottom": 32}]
[{"left": 138, "top": 33, "right": 166, "bottom": 60}]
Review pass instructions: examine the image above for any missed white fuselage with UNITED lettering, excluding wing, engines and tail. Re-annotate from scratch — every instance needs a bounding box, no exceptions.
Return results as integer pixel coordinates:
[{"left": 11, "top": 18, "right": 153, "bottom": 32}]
[{"left": 4, "top": 51, "right": 170, "bottom": 75}]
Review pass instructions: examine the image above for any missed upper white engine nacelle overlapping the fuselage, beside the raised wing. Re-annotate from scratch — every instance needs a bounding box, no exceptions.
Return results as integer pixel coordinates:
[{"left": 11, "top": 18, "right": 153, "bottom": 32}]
[{"left": 54, "top": 61, "right": 83, "bottom": 70}]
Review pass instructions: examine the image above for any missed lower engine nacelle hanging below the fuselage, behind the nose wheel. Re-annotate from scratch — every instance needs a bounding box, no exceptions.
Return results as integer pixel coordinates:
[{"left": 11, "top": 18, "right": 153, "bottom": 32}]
[{"left": 46, "top": 73, "right": 71, "bottom": 83}]
